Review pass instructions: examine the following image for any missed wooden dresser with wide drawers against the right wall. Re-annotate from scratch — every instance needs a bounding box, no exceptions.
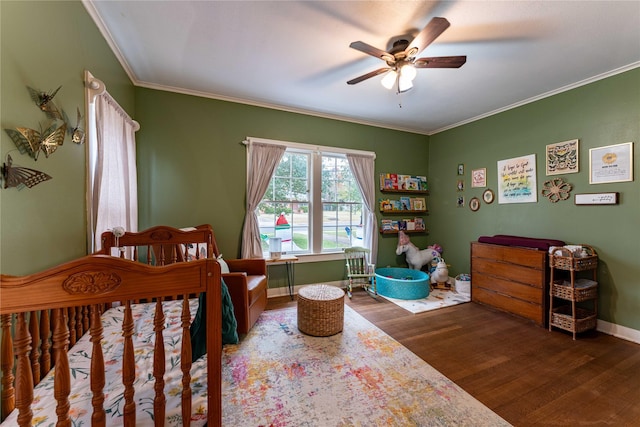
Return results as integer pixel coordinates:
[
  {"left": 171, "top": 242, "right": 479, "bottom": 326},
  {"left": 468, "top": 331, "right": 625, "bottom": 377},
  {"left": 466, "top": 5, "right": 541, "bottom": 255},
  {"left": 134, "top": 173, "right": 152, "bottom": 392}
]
[{"left": 471, "top": 242, "right": 549, "bottom": 327}]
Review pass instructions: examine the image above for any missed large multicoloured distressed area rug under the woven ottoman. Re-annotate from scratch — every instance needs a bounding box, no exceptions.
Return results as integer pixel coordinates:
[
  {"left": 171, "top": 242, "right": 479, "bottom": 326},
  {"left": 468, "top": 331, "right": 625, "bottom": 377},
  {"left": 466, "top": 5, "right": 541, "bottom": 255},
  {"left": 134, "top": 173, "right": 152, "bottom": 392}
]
[{"left": 222, "top": 306, "right": 509, "bottom": 427}]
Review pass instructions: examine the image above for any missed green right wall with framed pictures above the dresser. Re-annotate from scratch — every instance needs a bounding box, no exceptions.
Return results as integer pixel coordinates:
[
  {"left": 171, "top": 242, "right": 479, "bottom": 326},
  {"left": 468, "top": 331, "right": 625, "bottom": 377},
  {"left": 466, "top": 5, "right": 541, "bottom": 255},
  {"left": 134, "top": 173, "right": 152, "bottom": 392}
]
[{"left": 429, "top": 68, "right": 640, "bottom": 330}]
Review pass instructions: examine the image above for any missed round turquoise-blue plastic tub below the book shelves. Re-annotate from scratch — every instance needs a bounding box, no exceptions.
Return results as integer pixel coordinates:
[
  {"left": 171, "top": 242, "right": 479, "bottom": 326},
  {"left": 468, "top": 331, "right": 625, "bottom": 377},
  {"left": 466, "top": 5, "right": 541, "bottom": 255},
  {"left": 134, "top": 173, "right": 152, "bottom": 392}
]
[{"left": 376, "top": 267, "right": 429, "bottom": 299}]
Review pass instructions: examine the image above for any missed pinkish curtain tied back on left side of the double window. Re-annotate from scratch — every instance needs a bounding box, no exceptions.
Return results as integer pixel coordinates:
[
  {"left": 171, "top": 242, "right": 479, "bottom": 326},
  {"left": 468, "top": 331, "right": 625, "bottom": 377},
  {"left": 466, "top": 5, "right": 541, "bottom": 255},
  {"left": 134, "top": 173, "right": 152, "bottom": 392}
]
[{"left": 242, "top": 140, "right": 286, "bottom": 258}]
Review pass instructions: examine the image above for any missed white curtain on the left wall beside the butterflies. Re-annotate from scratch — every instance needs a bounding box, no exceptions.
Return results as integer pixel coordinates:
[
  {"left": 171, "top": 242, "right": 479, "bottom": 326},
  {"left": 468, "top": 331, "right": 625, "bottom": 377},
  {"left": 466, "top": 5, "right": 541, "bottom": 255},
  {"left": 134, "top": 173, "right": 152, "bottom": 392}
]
[{"left": 87, "top": 74, "right": 139, "bottom": 252}]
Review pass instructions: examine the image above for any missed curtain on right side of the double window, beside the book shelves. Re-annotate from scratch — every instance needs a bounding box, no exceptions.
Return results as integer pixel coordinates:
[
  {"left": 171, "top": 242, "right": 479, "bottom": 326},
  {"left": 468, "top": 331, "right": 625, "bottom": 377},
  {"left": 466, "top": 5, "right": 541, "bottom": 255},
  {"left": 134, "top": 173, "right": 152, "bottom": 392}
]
[{"left": 347, "top": 154, "right": 378, "bottom": 264}]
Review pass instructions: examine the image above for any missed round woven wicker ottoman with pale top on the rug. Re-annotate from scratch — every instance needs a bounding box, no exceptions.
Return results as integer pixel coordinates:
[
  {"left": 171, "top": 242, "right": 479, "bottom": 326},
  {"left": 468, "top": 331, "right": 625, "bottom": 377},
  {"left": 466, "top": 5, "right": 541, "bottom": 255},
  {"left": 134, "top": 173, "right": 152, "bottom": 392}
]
[{"left": 298, "top": 285, "right": 344, "bottom": 337}]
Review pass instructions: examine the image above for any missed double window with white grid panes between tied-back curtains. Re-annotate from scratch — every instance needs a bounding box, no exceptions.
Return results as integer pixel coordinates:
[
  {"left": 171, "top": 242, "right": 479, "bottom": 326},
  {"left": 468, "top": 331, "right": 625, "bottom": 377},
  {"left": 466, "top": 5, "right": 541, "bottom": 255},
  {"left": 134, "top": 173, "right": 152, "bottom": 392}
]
[{"left": 257, "top": 144, "right": 363, "bottom": 254}]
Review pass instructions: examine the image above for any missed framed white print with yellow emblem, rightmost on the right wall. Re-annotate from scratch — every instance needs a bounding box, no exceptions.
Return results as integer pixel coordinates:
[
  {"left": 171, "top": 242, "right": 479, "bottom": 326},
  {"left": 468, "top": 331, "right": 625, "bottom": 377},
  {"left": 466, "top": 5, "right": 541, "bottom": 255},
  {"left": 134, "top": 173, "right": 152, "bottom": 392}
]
[{"left": 589, "top": 142, "right": 633, "bottom": 184}]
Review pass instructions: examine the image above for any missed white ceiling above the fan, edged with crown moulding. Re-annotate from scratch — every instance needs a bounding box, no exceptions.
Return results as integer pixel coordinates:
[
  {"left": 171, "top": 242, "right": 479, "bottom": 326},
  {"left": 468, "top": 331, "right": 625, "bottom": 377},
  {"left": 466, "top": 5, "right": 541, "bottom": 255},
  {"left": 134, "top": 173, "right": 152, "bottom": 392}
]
[{"left": 83, "top": 0, "right": 640, "bottom": 134}]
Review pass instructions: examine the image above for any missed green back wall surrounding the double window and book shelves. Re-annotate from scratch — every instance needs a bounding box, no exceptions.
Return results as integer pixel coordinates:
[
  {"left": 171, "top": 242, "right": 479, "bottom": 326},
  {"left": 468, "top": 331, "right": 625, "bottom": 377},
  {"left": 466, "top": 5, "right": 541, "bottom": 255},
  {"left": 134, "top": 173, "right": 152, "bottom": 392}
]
[{"left": 136, "top": 88, "right": 429, "bottom": 287}]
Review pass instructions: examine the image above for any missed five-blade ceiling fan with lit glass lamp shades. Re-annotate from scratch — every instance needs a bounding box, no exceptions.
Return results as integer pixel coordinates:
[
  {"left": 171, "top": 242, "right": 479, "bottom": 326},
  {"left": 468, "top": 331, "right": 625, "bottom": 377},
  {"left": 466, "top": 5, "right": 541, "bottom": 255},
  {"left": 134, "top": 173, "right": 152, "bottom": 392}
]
[{"left": 347, "top": 17, "right": 467, "bottom": 93}]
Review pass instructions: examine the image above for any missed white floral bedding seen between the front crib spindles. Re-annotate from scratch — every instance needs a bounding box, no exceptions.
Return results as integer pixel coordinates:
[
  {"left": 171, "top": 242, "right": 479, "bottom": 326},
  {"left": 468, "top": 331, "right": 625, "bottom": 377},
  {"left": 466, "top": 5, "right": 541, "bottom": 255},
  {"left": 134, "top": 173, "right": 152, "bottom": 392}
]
[{"left": 2, "top": 298, "right": 207, "bottom": 426}]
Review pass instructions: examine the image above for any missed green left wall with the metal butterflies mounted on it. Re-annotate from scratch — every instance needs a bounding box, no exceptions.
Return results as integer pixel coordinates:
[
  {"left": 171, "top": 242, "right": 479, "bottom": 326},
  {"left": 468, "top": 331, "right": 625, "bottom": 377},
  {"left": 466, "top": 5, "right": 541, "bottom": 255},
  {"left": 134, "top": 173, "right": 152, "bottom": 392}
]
[{"left": 0, "top": 1, "right": 134, "bottom": 275}]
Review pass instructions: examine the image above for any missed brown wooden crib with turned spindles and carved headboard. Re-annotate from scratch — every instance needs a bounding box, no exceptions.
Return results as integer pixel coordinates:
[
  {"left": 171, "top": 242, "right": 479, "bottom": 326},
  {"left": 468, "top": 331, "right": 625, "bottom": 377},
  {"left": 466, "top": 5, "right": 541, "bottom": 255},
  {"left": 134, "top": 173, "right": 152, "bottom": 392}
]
[{"left": 0, "top": 227, "right": 222, "bottom": 426}]
